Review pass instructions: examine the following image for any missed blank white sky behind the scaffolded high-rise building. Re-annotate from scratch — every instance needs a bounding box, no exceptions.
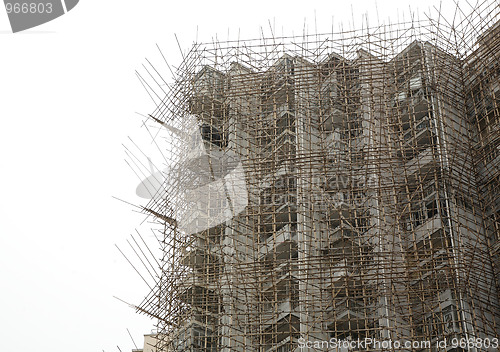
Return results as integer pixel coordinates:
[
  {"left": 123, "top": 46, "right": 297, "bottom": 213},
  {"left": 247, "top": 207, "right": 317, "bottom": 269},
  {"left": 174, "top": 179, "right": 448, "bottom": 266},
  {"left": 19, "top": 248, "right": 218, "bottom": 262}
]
[{"left": 0, "top": 0, "right": 482, "bottom": 352}]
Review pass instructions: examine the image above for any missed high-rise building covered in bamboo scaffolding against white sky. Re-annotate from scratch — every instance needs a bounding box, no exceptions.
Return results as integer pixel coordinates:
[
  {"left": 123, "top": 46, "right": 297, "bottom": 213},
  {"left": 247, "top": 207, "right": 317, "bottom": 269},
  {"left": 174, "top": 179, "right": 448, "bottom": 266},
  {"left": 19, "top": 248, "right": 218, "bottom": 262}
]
[{"left": 130, "top": 2, "right": 500, "bottom": 352}]
